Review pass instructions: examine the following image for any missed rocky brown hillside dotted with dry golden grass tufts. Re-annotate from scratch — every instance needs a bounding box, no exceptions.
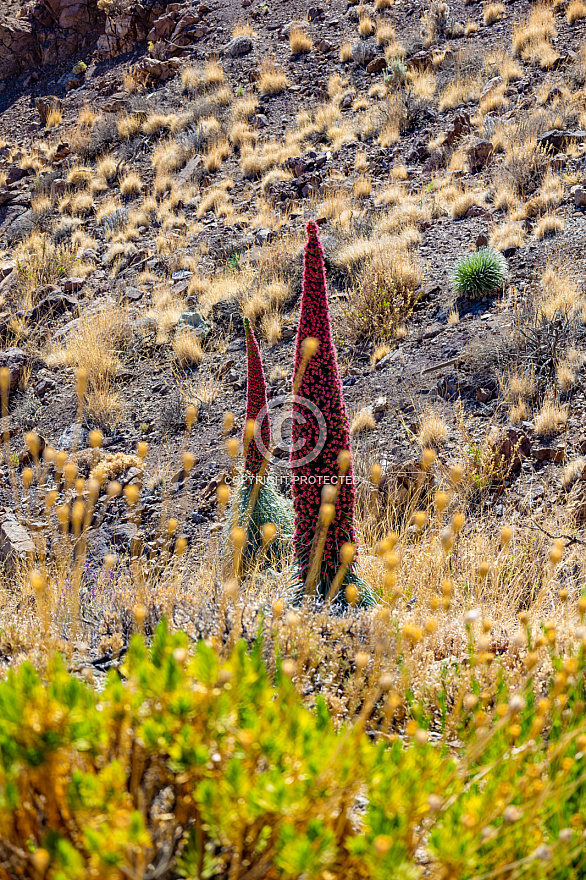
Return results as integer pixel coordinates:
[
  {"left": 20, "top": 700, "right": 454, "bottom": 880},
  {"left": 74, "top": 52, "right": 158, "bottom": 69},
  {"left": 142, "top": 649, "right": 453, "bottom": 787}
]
[{"left": 0, "top": 0, "right": 586, "bottom": 656}]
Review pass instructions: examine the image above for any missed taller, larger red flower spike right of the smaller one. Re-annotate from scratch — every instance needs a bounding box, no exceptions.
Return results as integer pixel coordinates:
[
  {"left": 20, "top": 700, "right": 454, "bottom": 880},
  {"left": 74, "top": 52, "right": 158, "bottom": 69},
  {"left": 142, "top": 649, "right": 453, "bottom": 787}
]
[{"left": 290, "top": 221, "right": 356, "bottom": 597}]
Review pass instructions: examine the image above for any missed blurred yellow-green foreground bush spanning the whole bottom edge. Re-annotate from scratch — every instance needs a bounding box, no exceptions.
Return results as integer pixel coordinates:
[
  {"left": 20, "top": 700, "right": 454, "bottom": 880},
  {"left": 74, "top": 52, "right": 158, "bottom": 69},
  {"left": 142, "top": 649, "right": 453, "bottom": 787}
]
[{"left": 0, "top": 625, "right": 586, "bottom": 880}]
